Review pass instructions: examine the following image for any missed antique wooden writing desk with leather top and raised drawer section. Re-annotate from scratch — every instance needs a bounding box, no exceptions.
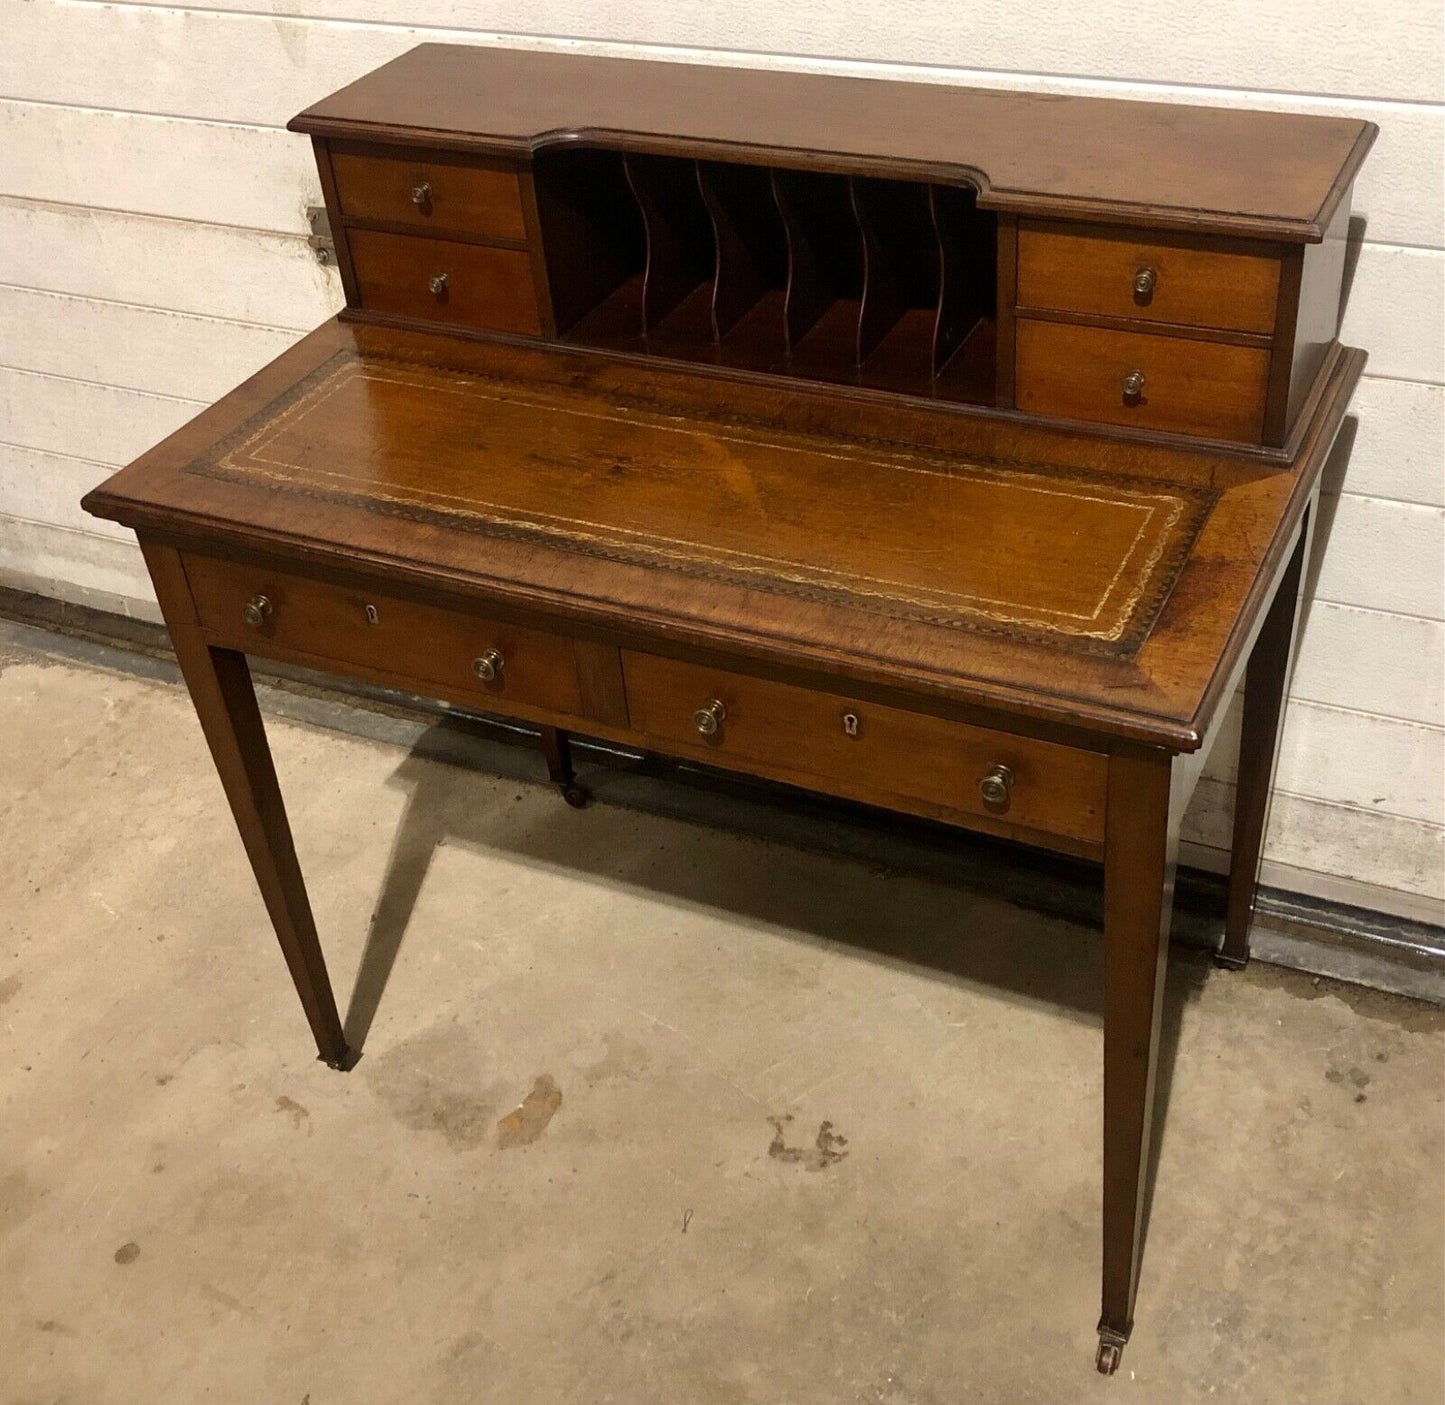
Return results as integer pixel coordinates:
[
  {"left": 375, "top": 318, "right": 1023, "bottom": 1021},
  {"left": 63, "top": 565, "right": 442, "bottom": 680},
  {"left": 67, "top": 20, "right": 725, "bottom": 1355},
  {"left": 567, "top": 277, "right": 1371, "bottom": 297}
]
[{"left": 85, "top": 45, "right": 1374, "bottom": 1372}]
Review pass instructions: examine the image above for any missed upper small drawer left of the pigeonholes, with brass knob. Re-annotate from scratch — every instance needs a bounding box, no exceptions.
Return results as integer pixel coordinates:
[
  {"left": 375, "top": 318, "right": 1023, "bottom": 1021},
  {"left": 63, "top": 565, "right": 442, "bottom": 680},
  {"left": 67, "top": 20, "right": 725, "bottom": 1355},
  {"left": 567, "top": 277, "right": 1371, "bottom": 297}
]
[{"left": 331, "top": 146, "right": 527, "bottom": 243}]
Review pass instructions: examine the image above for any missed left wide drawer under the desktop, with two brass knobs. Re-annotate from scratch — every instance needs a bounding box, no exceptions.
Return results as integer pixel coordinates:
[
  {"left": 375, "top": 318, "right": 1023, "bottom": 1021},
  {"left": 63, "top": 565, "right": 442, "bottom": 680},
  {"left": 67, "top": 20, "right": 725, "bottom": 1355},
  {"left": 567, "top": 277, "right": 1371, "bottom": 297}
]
[{"left": 185, "top": 555, "right": 592, "bottom": 721}]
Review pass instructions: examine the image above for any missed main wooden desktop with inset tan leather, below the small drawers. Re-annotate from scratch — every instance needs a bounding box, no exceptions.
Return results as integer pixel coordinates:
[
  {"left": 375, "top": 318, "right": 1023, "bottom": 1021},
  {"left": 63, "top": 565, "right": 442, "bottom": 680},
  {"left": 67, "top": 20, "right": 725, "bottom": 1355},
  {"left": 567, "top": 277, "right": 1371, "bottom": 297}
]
[{"left": 87, "top": 322, "right": 1358, "bottom": 749}]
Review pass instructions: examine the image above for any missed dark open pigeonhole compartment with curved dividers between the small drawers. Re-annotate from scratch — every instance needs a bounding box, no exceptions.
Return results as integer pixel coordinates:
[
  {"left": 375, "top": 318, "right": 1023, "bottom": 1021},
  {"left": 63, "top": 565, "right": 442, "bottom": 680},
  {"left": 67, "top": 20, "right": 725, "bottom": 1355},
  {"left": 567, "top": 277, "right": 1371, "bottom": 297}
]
[{"left": 533, "top": 147, "right": 997, "bottom": 405}]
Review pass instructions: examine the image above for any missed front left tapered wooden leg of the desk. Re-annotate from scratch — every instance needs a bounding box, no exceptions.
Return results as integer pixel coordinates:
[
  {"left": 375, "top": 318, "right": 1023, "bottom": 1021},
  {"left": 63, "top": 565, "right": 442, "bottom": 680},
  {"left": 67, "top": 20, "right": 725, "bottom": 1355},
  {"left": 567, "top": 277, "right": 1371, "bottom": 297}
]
[{"left": 145, "top": 545, "right": 355, "bottom": 1068}]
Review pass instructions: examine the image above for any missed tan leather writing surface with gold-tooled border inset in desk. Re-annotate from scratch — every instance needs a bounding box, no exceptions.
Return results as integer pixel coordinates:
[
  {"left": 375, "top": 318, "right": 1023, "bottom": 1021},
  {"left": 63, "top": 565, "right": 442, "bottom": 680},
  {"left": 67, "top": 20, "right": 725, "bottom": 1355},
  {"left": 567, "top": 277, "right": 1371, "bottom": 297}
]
[{"left": 191, "top": 353, "right": 1215, "bottom": 653}]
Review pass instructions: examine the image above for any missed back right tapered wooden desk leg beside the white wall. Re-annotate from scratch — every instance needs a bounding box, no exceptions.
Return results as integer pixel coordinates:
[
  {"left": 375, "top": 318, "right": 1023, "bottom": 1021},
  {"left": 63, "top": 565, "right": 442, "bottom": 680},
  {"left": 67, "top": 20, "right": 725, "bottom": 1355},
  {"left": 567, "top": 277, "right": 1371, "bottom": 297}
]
[{"left": 1215, "top": 512, "right": 1314, "bottom": 967}]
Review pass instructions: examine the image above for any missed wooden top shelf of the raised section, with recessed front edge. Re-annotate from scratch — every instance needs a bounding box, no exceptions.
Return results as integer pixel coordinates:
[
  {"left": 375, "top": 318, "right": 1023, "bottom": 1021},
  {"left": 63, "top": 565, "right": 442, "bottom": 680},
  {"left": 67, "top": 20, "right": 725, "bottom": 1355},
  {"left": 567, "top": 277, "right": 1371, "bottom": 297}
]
[{"left": 292, "top": 43, "right": 1377, "bottom": 241}]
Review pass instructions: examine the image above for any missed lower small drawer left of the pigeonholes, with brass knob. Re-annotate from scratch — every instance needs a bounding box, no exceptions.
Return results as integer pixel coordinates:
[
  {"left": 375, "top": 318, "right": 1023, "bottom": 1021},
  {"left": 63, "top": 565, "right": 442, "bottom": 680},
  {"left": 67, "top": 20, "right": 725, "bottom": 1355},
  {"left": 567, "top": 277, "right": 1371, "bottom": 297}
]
[{"left": 348, "top": 230, "right": 542, "bottom": 337}]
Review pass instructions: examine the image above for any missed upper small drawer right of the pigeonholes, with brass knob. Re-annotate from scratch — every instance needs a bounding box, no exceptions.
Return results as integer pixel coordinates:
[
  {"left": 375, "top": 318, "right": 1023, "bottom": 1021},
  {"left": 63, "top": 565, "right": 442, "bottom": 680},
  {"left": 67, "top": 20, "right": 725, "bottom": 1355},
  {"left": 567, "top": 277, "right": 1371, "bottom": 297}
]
[{"left": 1019, "top": 221, "right": 1280, "bottom": 332}]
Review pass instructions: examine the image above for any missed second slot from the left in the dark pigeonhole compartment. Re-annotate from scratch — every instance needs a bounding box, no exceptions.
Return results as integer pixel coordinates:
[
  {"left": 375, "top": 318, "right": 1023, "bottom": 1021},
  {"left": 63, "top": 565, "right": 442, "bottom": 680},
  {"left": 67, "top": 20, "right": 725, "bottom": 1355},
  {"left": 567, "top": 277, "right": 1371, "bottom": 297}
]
[{"left": 624, "top": 153, "right": 717, "bottom": 360}]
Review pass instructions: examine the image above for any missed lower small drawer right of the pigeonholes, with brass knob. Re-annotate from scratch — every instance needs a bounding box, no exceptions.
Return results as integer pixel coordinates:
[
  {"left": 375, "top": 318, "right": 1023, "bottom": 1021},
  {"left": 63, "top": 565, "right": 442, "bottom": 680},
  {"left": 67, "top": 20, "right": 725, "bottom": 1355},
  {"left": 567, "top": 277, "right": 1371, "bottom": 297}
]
[{"left": 1014, "top": 317, "right": 1270, "bottom": 444}]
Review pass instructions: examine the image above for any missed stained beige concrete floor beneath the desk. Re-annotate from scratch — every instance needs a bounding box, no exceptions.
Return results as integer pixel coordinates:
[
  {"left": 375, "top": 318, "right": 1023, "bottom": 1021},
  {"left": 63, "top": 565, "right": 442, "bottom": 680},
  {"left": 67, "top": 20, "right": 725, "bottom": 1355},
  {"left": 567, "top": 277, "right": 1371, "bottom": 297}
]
[{"left": 0, "top": 635, "right": 1445, "bottom": 1405}]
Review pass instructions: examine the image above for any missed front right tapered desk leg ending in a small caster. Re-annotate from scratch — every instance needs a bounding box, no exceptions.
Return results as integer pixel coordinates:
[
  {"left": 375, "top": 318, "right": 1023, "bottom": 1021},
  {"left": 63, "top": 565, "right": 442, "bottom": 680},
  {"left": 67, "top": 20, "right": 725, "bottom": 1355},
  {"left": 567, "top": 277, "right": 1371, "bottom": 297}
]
[{"left": 1097, "top": 752, "right": 1178, "bottom": 1375}]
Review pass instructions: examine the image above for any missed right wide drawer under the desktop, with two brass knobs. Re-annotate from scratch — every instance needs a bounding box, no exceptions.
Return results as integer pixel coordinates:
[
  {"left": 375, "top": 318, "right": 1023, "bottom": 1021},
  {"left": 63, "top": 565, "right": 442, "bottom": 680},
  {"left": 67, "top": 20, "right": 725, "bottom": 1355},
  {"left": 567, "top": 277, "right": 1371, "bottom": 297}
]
[{"left": 623, "top": 649, "right": 1107, "bottom": 846}]
